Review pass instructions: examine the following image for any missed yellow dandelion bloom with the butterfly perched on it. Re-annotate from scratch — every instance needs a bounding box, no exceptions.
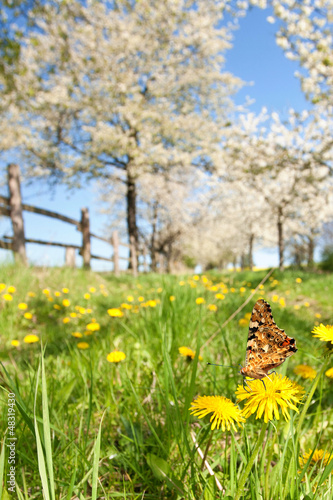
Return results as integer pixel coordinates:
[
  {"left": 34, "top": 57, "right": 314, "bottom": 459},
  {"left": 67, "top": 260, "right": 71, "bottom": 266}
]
[{"left": 236, "top": 374, "right": 301, "bottom": 423}]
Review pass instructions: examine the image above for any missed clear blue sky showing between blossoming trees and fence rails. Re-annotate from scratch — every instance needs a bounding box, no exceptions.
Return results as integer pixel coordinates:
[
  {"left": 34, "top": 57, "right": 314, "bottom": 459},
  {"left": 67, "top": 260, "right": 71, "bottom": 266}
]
[{"left": 0, "top": 8, "right": 309, "bottom": 270}]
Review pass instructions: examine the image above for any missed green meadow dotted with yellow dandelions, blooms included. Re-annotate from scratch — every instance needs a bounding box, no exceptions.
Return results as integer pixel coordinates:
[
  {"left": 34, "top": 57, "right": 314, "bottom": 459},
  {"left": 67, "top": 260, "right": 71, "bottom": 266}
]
[{"left": 0, "top": 266, "right": 333, "bottom": 500}]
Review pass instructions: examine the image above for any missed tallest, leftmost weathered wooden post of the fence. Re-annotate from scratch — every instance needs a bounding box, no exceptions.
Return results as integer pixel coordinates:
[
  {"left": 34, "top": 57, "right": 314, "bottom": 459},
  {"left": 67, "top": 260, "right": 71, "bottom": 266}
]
[{"left": 8, "top": 163, "right": 27, "bottom": 265}]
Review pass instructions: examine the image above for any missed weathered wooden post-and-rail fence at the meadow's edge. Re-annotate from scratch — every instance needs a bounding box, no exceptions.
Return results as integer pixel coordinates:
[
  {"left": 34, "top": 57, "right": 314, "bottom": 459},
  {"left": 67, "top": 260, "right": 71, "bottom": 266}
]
[{"left": 0, "top": 164, "right": 148, "bottom": 276}]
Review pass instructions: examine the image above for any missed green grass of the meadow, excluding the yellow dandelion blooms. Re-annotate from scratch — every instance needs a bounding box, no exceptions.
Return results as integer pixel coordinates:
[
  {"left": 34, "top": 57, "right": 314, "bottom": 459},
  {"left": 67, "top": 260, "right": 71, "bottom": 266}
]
[{"left": 0, "top": 267, "right": 333, "bottom": 499}]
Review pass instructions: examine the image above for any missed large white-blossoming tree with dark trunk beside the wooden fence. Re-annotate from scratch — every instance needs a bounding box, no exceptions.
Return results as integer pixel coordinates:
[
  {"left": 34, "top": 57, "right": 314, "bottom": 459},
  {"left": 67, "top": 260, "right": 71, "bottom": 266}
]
[{"left": 9, "top": 0, "right": 241, "bottom": 252}]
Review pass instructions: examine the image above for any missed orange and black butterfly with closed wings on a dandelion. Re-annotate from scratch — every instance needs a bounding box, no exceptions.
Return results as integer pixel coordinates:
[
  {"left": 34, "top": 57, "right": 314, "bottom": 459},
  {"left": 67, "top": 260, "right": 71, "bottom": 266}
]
[{"left": 240, "top": 299, "right": 297, "bottom": 385}]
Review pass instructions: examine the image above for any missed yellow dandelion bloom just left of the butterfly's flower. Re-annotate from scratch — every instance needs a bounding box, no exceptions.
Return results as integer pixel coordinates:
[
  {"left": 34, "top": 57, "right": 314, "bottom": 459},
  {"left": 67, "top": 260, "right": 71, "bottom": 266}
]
[{"left": 189, "top": 396, "right": 245, "bottom": 431}]
